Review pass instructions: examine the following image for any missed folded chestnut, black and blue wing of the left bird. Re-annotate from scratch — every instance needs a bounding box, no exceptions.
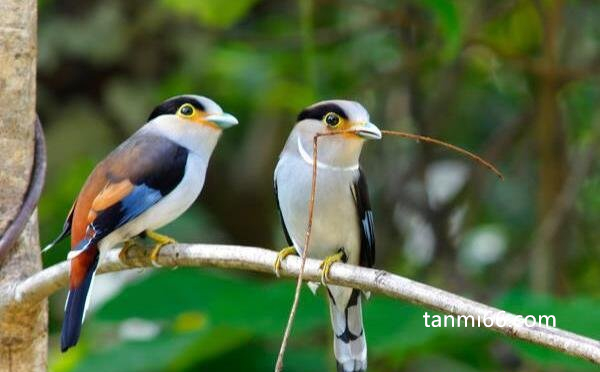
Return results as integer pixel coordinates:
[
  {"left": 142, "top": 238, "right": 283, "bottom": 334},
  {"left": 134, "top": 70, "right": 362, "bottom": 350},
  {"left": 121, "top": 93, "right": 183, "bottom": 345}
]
[{"left": 69, "top": 135, "right": 188, "bottom": 257}]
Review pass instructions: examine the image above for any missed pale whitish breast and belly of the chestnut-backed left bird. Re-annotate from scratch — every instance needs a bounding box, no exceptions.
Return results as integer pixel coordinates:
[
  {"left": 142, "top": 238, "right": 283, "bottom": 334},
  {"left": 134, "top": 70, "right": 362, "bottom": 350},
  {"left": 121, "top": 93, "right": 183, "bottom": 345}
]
[{"left": 100, "top": 152, "right": 207, "bottom": 251}]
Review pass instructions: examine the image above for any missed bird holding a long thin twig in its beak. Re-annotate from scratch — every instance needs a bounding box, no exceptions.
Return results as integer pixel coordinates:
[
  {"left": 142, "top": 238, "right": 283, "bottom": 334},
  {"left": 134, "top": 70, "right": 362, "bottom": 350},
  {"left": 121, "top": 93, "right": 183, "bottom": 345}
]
[{"left": 274, "top": 100, "right": 381, "bottom": 372}]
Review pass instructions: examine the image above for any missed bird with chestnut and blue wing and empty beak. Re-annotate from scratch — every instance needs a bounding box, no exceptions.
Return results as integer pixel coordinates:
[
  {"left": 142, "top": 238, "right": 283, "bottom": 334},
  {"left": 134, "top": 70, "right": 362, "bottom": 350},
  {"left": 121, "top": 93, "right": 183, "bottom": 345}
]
[{"left": 45, "top": 95, "right": 238, "bottom": 352}]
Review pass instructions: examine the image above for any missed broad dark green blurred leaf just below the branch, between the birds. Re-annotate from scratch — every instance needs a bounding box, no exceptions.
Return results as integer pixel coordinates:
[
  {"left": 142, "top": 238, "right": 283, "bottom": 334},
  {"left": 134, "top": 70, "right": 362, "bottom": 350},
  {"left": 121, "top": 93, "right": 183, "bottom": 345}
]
[{"left": 97, "top": 269, "right": 328, "bottom": 337}]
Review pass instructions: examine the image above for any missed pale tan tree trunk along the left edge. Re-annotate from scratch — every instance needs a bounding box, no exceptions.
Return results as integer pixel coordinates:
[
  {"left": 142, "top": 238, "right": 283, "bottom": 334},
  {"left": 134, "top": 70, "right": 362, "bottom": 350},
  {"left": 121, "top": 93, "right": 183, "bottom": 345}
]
[{"left": 0, "top": 0, "right": 48, "bottom": 372}]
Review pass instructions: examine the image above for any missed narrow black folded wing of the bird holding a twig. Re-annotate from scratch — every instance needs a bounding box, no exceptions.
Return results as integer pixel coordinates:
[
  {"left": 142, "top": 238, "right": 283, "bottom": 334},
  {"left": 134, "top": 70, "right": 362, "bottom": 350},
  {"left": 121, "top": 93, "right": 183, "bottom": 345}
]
[{"left": 352, "top": 169, "right": 375, "bottom": 267}]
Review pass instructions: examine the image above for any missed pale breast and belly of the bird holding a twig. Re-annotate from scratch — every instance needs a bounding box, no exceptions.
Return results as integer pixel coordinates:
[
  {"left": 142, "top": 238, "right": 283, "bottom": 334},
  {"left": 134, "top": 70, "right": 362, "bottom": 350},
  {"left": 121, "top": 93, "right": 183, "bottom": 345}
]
[{"left": 276, "top": 156, "right": 360, "bottom": 264}]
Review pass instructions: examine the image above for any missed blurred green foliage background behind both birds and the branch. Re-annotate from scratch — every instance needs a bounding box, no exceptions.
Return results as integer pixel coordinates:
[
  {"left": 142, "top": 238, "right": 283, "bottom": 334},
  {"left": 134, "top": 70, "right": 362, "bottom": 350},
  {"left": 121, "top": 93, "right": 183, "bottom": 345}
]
[{"left": 38, "top": 0, "right": 600, "bottom": 372}]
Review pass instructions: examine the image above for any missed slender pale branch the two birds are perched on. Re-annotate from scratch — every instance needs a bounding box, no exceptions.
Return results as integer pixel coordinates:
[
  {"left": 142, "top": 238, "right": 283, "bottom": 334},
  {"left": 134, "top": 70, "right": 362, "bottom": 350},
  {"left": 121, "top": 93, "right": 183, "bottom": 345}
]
[{"left": 0, "top": 244, "right": 600, "bottom": 364}]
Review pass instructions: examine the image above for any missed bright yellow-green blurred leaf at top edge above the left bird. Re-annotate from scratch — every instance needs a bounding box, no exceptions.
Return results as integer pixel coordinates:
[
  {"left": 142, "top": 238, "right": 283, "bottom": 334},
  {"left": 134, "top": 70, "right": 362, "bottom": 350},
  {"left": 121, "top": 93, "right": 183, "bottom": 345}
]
[{"left": 161, "top": 0, "right": 258, "bottom": 28}]
